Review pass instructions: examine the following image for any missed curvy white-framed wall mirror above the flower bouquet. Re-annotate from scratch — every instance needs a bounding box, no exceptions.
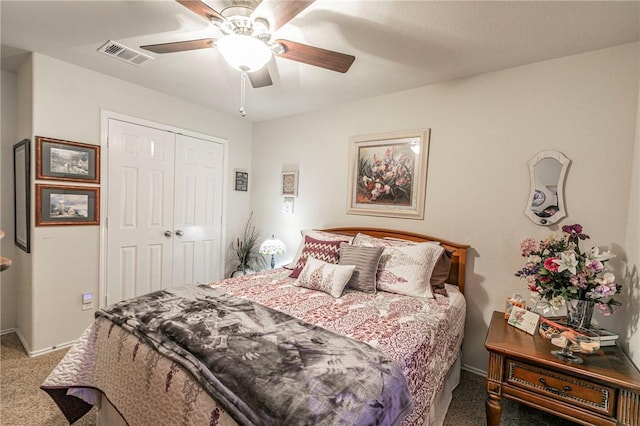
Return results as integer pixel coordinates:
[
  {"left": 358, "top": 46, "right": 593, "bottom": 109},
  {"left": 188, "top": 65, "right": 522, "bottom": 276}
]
[{"left": 524, "top": 151, "right": 571, "bottom": 226}]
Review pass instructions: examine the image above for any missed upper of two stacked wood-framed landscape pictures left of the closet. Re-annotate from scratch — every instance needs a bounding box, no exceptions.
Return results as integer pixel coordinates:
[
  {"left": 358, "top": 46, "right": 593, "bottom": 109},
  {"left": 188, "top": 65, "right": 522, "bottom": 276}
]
[{"left": 36, "top": 136, "right": 100, "bottom": 183}]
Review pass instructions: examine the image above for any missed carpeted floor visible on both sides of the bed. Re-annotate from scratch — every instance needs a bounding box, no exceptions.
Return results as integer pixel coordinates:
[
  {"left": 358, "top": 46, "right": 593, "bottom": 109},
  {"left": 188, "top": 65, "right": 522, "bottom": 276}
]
[{"left": 0, "top": 334, "right": 574, "bottom": 426}]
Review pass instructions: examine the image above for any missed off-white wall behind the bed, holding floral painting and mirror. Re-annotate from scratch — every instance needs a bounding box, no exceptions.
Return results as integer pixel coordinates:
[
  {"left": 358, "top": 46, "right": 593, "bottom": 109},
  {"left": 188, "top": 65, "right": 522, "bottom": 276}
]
[{"left": 252, "top": 43, "right": 639, "bottom": 370}]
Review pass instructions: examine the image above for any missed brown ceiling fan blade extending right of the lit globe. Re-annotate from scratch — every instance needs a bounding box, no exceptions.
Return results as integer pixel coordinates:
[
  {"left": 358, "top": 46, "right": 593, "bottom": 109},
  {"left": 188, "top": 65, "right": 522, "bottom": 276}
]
[{"left": 275, "top": 40, "right": 356, "bottom": 73}]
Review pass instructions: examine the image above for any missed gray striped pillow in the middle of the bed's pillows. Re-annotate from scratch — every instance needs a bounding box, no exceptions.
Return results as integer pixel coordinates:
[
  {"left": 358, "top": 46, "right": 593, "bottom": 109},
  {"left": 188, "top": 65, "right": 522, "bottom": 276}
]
[{"left": 338, "top": 243, "right": 384, "bottom": 293}]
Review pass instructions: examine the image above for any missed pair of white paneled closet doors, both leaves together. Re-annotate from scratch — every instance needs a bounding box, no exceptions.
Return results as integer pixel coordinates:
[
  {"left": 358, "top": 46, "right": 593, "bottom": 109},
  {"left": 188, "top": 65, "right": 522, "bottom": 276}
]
[{"left": 105, "top": 119, "right": 224, "bottom": 305}]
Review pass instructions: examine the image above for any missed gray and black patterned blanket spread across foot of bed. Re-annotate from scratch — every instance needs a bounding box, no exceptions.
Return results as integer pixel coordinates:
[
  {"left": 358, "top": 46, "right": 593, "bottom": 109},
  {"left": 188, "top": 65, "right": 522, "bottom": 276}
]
[{"left": 62, "top": 286, "right": 412, "bottom": 425}]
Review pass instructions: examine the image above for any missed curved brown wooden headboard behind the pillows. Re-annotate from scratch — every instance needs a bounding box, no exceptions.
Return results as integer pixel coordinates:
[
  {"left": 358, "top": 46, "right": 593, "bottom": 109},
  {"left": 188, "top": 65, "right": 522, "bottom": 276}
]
[{"left": 322, "top": 227, "right": 469, "bottom": 293}]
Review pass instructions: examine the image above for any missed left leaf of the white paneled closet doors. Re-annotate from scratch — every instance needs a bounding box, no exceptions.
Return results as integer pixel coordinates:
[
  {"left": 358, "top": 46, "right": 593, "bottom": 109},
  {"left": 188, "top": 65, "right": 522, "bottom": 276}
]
[{"left": 103, "top": 119, "right": 175, "bottom": 304}]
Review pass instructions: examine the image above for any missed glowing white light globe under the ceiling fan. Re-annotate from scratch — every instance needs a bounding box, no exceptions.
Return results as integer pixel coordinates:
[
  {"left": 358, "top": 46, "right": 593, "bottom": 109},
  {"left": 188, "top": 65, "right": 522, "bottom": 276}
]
[{"left": 216, "top": 34, "right": 273, "bottom": 72}]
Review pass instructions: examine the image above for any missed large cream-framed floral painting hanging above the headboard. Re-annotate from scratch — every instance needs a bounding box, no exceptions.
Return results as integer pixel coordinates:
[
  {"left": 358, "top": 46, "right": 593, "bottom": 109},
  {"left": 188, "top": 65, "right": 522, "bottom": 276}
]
[{"left": 347, "top": 129, "right": 430, "bottom": 219}]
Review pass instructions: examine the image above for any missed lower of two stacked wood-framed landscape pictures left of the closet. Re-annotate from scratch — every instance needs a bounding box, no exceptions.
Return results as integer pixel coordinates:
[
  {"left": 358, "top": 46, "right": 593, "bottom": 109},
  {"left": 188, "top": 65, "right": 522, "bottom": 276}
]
[{"left": 36, "top": 185, "right": 100, "bottom": 226}]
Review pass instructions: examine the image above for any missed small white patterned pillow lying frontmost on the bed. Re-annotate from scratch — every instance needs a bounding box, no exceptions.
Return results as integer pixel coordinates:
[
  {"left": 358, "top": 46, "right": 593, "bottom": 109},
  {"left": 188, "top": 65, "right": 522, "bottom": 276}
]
[{"left": 294, "top": 257, "right": 355, "bottom": 299}]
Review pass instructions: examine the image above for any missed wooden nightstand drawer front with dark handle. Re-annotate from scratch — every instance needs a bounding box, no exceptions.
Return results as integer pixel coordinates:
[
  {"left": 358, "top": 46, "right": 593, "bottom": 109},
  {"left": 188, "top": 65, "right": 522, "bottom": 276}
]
[{"left": 506, "top": 359, "right": 615, "bottom": 416}]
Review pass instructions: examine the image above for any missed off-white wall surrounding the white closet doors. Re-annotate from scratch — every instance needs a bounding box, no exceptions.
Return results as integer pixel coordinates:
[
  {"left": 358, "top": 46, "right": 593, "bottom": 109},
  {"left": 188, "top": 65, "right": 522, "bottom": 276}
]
[{"left": 16, "top": 53, "right": 252, "bottom": 352}]
